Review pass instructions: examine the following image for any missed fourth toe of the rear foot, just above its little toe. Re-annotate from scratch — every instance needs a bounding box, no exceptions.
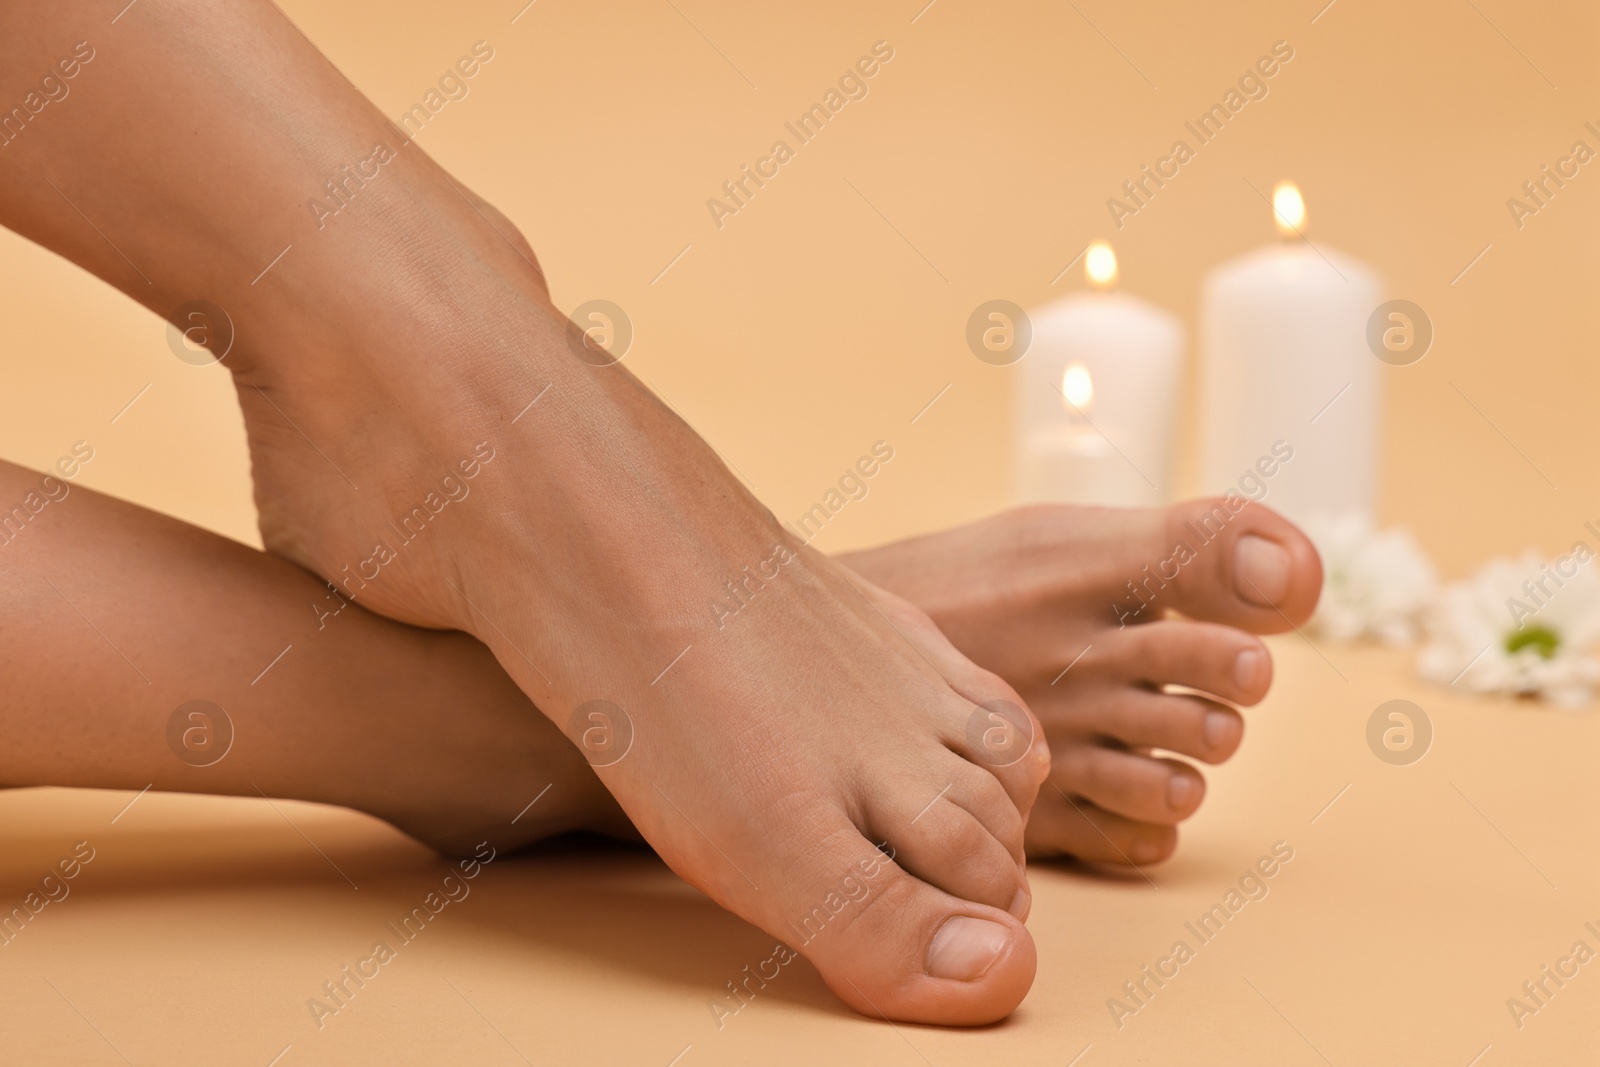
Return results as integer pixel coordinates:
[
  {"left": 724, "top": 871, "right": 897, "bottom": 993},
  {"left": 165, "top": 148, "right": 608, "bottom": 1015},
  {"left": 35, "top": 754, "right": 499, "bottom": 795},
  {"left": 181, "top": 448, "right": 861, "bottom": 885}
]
[{"left": 1050, "top": 742, "right": 1205, "bottom": 824}]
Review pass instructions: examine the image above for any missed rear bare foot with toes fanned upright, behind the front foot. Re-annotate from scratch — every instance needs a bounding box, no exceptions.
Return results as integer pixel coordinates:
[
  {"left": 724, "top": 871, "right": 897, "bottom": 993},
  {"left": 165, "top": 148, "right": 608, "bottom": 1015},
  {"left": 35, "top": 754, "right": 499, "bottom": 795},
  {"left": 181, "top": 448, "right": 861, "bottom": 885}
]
[{"left": 843, "top": 499, "right": 1322, "bottom": 864}]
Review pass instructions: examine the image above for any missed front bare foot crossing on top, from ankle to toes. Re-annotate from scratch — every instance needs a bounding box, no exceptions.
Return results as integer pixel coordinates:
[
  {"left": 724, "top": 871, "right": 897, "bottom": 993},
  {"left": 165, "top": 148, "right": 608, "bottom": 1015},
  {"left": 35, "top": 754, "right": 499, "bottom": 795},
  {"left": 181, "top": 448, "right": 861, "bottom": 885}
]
[{"left": 216, "top": 175, "right": 1048, "bottom": 1024}]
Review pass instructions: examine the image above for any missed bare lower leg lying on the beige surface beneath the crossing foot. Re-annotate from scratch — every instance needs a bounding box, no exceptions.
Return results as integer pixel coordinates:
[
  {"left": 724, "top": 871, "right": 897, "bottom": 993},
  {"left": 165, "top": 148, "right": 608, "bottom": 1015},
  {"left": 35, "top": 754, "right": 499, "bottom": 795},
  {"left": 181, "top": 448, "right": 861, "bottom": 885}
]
[{"left": 0, "top": 462, "right": 632, "bottom": 851}]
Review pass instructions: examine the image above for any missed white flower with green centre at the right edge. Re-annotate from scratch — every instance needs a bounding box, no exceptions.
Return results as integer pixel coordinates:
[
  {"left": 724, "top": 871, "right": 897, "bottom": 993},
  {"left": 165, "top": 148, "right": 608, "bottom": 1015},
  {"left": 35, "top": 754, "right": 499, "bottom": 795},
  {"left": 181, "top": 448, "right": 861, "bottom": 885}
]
[{"left": 1418, "top": 542, "right": 1600, "bottom": 707}]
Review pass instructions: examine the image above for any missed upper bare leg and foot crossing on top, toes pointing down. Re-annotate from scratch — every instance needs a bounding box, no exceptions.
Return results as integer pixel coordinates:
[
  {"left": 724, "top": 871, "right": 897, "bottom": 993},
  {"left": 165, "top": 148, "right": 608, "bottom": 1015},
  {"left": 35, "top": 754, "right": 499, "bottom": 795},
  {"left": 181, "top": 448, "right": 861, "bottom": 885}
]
[{"left": 0, "top": 0, "right": 1324, "bottom": 1024}]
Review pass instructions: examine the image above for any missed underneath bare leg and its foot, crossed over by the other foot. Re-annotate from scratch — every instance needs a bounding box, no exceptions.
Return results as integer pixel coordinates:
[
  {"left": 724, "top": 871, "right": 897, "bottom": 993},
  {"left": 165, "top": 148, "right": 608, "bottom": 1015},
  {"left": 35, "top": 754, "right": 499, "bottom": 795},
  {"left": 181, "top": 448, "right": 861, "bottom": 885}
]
[{"left": 0, "top": 451, "right": 1320, "bottom": 864}]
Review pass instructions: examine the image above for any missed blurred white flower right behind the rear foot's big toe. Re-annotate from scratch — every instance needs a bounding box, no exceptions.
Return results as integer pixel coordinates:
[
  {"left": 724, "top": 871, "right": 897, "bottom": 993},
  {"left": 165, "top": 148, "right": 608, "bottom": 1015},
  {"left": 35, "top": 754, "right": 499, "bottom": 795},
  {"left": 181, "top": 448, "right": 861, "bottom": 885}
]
[{"left": 1306, "top": 514, "right": 1438, "bottom": 645}]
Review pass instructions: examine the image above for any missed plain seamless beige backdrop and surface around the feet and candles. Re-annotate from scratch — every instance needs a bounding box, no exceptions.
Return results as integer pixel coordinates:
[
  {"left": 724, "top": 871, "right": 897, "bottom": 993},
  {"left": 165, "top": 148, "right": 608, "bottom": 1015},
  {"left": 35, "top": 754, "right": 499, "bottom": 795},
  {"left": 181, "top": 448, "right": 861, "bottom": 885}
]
[{"left": 0, "top": 0, "right": 1600, "bottom": 1065}]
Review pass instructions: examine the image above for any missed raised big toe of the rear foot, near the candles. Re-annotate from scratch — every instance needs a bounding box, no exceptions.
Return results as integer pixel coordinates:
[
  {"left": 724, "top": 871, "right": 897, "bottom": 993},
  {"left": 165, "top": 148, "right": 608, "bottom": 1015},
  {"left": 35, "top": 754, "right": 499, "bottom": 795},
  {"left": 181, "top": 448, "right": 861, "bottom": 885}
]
[{"left": 1155, "top": 498, "right": 1322, "bottom": 633}]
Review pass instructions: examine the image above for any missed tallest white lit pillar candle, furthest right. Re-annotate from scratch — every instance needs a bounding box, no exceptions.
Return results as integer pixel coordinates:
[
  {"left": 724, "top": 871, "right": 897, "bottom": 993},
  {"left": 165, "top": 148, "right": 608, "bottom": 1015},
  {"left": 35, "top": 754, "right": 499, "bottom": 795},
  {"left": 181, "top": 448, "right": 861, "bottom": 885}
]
[{"left": 1200, "top": 182, "right": 1382, "bottom": 520}]
